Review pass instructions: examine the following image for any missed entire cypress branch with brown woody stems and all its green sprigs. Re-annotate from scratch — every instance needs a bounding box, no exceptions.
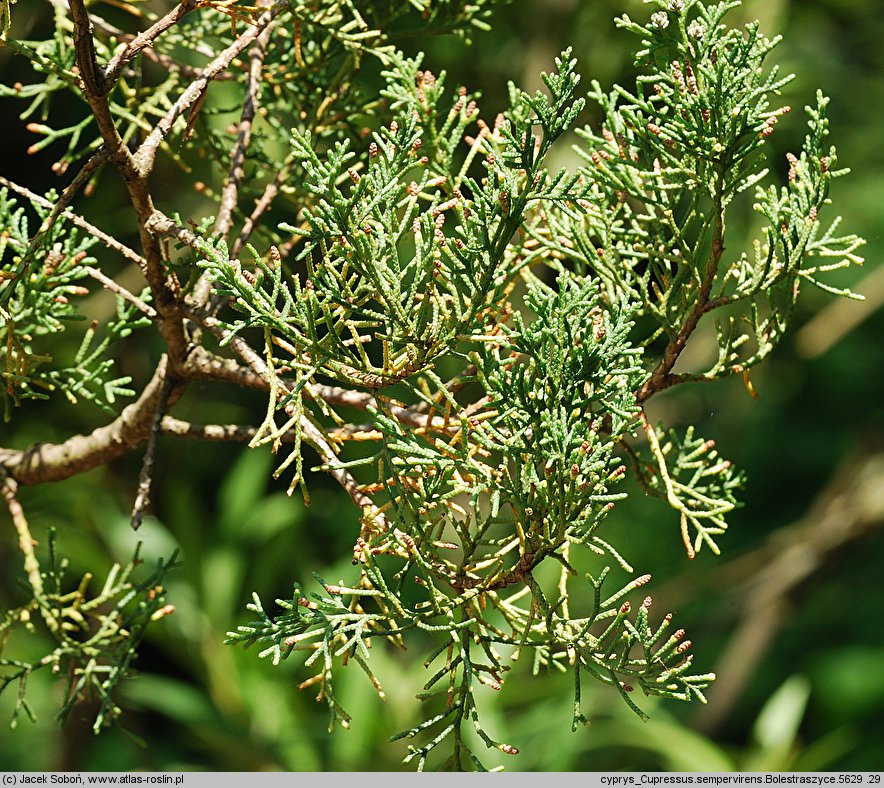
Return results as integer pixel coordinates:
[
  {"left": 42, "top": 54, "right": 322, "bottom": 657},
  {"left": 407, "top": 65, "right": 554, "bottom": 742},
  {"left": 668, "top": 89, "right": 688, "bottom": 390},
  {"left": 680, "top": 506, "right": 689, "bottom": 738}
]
[{"left": 0, "top": 0, "right": 861, "bottom": 769}]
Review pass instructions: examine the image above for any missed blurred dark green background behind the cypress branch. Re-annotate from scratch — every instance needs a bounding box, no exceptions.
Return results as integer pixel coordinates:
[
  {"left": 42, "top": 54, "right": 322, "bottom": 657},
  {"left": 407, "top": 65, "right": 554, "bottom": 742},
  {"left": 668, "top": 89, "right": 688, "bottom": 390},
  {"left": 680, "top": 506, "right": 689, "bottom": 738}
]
[{"left": 0, "top": 0, "right": 884, "bottom": 771}]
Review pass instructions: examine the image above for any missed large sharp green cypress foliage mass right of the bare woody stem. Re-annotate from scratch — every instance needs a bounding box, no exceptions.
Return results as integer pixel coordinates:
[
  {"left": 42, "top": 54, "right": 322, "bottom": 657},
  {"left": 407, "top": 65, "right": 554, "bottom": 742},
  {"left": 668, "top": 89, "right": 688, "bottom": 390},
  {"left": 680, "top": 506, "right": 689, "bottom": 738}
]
[{"left": 221, "top": 2, "right": 858, "bottom": 768}]
